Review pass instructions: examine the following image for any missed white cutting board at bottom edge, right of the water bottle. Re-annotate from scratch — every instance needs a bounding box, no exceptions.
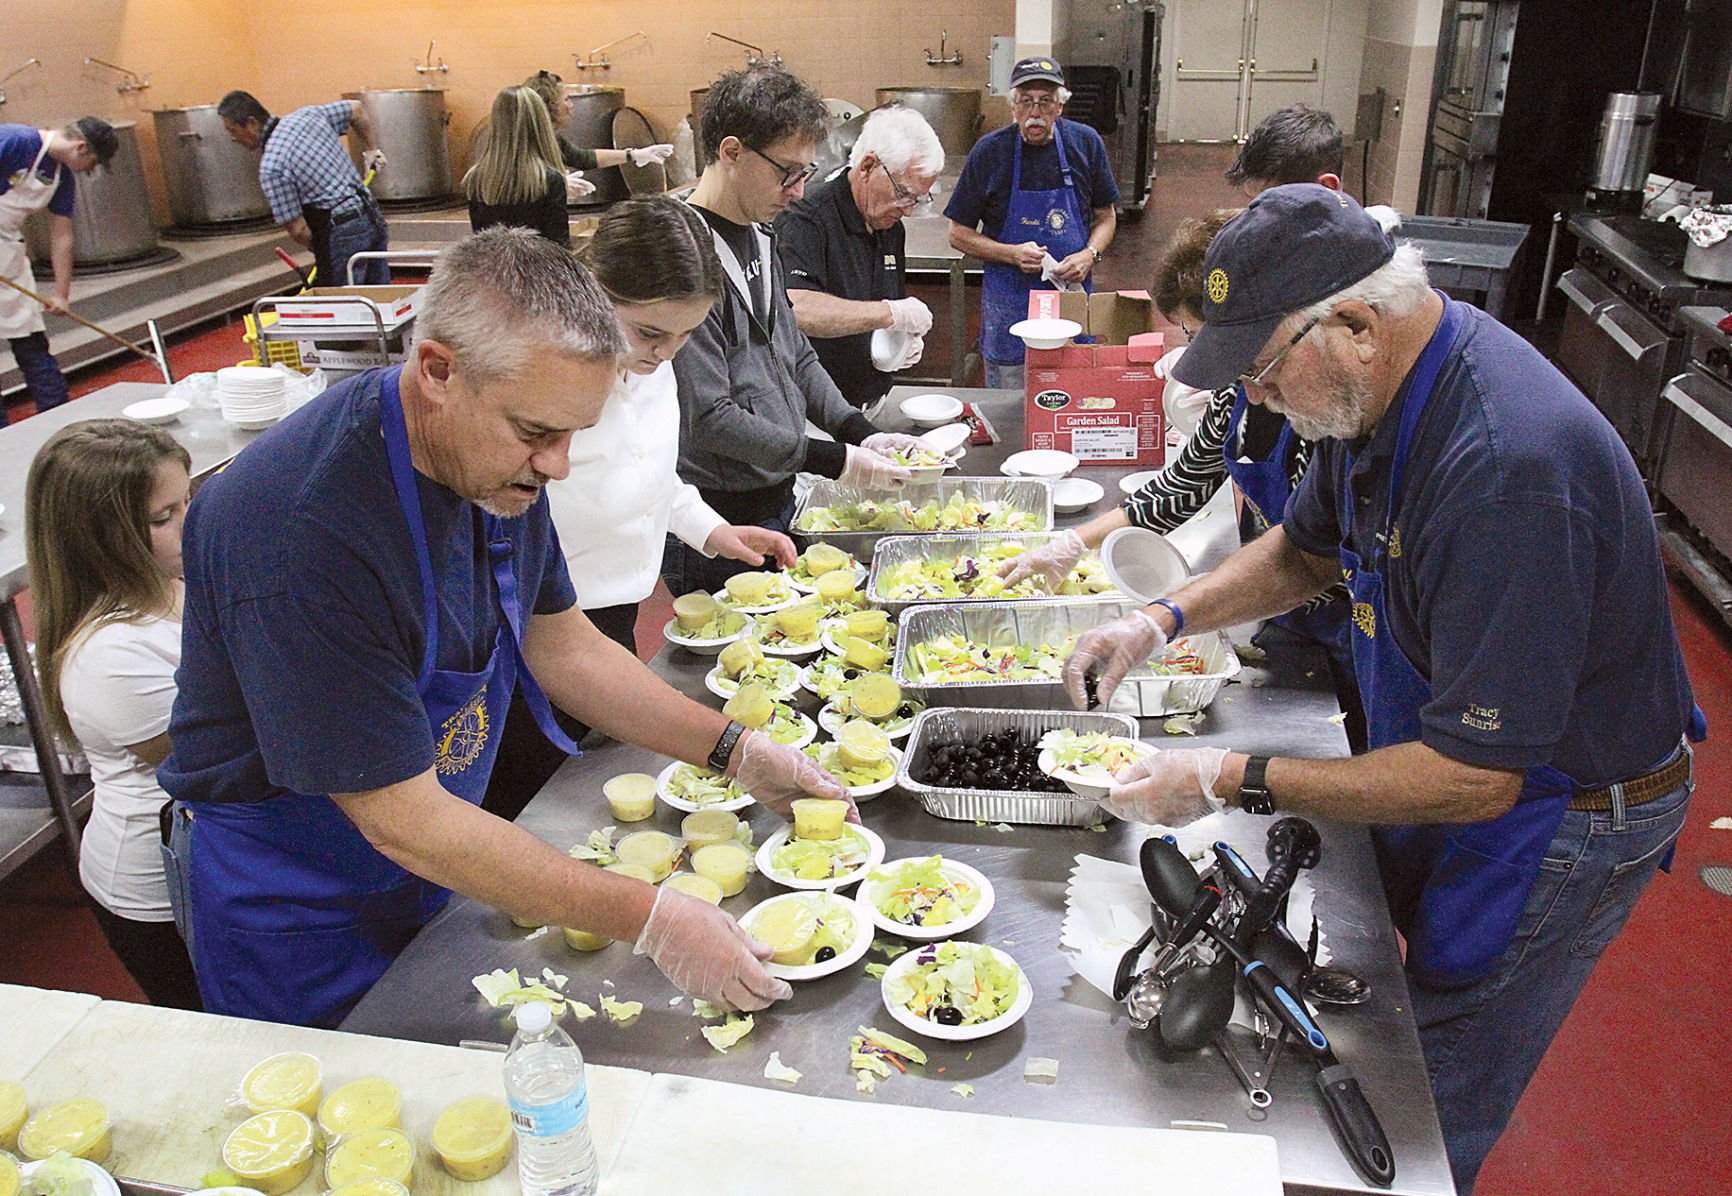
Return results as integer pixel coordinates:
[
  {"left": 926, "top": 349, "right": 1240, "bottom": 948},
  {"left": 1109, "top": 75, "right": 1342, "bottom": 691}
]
[{"left": 601, "top": 1075, "right": 1282, "bottom": 1196}]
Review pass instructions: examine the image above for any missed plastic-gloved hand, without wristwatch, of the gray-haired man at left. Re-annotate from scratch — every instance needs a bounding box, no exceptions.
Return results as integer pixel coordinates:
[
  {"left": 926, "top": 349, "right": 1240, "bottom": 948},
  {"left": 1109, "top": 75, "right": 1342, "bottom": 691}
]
[{"left": 632, "top": 886, "right": 793, "bottom": 1011}]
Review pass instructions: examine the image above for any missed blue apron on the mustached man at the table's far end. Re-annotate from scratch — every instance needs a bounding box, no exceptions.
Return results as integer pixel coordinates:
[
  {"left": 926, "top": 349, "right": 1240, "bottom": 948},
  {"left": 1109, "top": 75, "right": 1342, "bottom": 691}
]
[{"left": 980, "top": 119, "right": 1095, "bottom": 365}]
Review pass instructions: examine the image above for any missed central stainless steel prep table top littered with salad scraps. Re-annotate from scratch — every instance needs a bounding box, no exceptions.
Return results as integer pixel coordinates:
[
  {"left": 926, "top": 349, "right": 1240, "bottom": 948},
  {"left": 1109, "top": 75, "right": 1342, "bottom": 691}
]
[{"left": 343, "top": 388, "right": 1453, "bottom": 1194}]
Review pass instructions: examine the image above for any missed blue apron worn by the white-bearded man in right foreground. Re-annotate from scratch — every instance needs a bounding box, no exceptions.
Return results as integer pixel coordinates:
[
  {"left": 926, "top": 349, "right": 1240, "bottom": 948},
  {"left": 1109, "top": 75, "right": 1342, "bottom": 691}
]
[{"left": 1341, "top": 299, "right": 1574, "bottom": 988}]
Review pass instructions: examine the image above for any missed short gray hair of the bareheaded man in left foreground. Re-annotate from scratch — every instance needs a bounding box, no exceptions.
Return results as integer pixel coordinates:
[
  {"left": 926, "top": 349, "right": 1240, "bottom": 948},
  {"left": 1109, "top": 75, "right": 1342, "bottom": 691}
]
[{"left": 414, "top": 227, "right": 625, "bottom": 386}]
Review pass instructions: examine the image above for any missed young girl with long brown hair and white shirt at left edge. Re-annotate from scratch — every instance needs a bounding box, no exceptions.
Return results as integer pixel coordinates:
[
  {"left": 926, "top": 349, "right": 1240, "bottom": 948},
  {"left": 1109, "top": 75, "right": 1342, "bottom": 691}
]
[{"left": 24, "top": 419, "right": 199, "bottom": 1009}]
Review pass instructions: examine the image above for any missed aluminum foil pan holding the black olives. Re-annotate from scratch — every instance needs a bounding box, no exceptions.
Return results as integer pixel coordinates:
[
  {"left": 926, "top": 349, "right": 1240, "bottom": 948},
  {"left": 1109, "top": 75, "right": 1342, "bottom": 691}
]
[{"left": 895, "top": 706, "right": 1138, "bottom": 826}]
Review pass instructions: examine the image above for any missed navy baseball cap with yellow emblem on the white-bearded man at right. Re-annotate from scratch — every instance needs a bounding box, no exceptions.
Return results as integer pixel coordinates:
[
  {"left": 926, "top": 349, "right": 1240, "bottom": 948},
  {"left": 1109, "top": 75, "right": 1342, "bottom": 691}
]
[{"left": 1173, "top": 183, "right": 1396, "bottom": 391}]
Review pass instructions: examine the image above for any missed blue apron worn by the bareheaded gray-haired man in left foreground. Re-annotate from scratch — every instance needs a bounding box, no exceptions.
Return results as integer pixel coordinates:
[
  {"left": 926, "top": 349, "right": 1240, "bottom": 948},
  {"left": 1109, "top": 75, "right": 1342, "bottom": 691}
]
[{"left": 189, "top": 370, "right": 578, "bottom": 1026}]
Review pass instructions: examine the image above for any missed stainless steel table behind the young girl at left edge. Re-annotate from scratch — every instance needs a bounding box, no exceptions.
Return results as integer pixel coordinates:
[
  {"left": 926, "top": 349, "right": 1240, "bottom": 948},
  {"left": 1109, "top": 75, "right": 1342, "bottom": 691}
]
[{"left": 0, "top": 383, "right": 258, "bottom": 876}]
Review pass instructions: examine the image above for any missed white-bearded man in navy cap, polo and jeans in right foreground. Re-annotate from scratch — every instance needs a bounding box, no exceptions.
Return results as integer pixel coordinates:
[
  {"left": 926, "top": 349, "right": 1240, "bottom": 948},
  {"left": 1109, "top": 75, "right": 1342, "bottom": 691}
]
[{"left": 1065, "top": 183, "right": 1703, "bottom": 1193}]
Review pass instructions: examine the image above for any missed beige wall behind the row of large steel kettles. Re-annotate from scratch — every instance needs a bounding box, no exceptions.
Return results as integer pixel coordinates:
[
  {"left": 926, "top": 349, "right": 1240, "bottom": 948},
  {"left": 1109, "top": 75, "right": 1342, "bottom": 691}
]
[{"left": 0, "top": 0, "right": 1017, "bottom": 222}]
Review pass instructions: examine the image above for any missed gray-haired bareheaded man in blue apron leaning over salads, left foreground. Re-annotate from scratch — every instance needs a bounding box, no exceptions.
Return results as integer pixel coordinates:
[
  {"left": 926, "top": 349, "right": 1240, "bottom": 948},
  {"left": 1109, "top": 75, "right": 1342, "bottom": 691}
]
[{"left": 159, "top": 228, "right": 843, "bottom": 1026}]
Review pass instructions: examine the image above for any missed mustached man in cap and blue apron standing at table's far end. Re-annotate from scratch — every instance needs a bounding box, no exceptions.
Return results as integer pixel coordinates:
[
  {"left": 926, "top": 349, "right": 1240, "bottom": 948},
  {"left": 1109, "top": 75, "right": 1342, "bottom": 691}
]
[{"left": 944, "top": 59, "right": 1119, "bottom": 389}]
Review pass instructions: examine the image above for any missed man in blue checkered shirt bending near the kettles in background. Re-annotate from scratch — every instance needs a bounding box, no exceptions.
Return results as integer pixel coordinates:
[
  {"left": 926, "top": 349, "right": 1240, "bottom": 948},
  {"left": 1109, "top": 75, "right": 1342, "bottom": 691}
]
[{"left": 217, "top": 92, "right": 391, "bottom": 287}]
